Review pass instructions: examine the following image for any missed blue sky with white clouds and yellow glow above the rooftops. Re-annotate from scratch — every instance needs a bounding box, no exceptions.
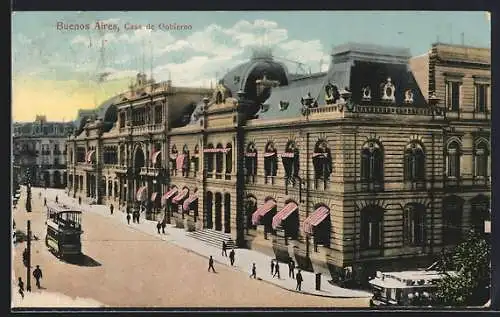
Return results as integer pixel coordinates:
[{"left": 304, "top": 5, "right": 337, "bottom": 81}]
[{"left": 12, "top": 11, "right": 490, "bottom": 121}]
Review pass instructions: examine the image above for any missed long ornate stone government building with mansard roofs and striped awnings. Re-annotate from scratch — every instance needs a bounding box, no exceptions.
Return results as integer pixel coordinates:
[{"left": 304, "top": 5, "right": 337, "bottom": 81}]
[{"left": 67, "top": 43, "right": 491, "bottom": 281}]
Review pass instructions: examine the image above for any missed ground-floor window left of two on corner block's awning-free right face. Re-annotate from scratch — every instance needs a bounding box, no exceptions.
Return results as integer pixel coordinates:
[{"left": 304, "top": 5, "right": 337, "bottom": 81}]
[{"left": 361, "top": 206, "right": 384, "bottom": 249}]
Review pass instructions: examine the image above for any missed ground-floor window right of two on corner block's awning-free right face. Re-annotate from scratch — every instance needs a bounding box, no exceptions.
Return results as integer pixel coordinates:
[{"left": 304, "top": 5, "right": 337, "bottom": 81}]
[{"left": 403, "top": 204, "right": 425, "bottom": 245}]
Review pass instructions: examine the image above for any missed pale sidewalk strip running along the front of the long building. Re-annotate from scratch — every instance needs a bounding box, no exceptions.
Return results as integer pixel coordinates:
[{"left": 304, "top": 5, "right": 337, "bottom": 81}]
[{"left": 47, "top": 189, "right": 372, "bottom": 298}]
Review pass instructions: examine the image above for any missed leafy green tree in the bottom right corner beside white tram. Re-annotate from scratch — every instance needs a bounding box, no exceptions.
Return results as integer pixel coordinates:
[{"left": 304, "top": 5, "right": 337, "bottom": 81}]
[{"left": 435, "top": 231, "right": 491, "bottom": 306}]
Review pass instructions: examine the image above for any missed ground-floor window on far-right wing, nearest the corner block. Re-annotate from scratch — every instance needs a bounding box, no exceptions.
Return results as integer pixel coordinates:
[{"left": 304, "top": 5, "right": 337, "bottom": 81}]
[{"left": 442, "top": 196, "right": 463, "bottom": 244}]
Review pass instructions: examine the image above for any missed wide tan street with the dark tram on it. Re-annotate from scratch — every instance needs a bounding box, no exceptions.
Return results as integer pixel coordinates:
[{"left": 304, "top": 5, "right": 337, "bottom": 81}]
[{"left": 13, "top": 187, "right": 368, "bottom": 308}]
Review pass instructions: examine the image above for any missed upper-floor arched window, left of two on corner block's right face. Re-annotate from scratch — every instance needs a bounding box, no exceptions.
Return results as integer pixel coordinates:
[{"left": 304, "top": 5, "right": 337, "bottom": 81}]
[{"left": 361, "top": 141, "right": 384, "bottom": 189}]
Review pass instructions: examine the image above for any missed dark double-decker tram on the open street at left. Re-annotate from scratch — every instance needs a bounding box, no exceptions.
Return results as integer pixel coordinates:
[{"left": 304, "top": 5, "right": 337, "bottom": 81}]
[{"left": 45, "top": 202, "right": 83, "bottom": 257}]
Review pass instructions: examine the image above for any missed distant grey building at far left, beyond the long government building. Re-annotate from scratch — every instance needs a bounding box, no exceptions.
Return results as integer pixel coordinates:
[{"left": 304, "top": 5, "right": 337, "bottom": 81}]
[{"left": 12, "top": 116, "right": 73, "bottom": 188}]
